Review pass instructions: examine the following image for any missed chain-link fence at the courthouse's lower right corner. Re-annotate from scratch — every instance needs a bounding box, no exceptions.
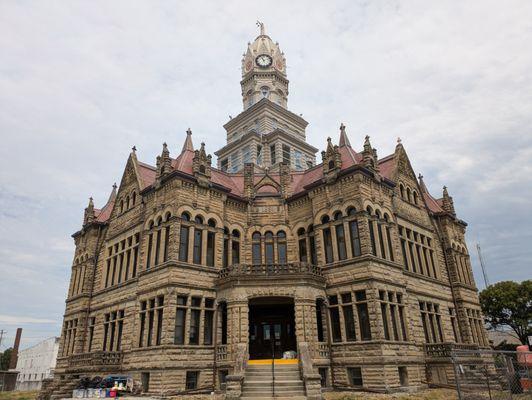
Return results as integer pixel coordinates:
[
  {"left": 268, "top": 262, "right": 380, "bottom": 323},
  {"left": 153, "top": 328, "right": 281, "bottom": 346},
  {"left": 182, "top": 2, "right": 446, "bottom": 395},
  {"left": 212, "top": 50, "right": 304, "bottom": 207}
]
[{"left": 451, "top": 349, "right": 532, "bottom": 400}]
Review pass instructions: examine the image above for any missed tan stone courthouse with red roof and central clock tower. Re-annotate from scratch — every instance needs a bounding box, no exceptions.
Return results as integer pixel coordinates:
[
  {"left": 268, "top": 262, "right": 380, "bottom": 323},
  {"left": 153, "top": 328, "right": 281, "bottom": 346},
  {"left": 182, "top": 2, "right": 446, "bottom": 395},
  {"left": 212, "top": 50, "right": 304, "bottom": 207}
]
[{"left": 47, "top": 26, "right": 488, "bottom": 399}]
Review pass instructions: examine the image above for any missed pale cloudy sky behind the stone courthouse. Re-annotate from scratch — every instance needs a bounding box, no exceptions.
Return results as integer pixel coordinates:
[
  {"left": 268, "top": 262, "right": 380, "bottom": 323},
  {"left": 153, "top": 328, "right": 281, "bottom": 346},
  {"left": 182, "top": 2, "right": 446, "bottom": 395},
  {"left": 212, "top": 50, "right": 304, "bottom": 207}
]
[{"left": 0, "top": 0, "right": 532, "bottom": 351}]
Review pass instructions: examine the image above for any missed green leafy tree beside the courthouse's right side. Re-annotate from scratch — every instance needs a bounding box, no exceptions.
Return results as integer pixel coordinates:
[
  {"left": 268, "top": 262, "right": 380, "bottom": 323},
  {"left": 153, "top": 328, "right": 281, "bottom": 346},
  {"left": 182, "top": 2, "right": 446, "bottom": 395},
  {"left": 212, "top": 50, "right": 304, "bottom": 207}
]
[{"left": 480, "top": 280, "right": 532, "bottom": 344}]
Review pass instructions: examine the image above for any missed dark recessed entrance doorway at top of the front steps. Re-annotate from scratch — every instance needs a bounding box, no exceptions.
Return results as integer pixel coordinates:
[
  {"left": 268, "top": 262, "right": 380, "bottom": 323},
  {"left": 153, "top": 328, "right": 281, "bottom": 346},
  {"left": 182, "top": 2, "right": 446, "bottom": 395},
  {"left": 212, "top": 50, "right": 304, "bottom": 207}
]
[{"left": 249, "top": 297, "right": 297, "bottom": 360}]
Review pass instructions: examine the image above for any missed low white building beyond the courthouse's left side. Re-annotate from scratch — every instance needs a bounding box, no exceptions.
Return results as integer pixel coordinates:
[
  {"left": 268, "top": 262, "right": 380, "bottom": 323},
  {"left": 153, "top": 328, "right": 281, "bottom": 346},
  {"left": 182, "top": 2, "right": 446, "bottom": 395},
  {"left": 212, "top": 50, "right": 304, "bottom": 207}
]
[{"left": 15, "top": 337, "right": 59, "bottom": 390}]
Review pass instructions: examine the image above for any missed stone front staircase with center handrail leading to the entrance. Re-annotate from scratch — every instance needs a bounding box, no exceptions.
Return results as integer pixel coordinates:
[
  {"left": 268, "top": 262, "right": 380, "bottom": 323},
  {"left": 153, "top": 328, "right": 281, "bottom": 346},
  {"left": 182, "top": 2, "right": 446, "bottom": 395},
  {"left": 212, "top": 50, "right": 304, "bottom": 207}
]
[{"left": 241, "top": 364, "right": 306, "bottom": 400}]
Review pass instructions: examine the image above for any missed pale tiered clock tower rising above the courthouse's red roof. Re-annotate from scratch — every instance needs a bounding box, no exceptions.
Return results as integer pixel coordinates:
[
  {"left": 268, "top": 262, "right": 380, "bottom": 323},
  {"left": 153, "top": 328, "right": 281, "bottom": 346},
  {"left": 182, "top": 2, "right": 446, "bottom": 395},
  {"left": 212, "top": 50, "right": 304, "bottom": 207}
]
[{"left": 215, "top": 22, "right": 318, "bottom": 173}]
